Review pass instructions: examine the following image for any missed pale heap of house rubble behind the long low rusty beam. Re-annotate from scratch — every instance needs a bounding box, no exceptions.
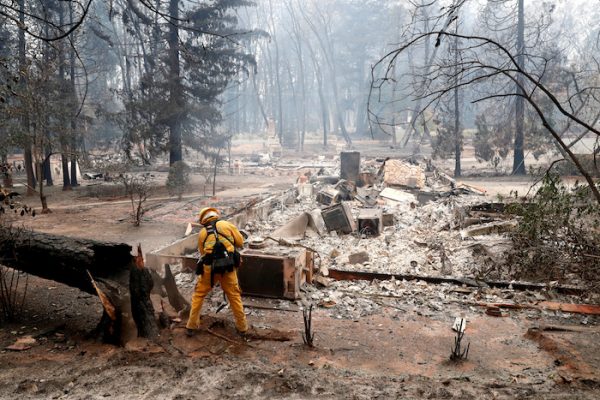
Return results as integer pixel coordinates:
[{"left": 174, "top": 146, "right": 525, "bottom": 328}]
[{"left": 244, "top": 152, "right": 516, "bottom": 279}]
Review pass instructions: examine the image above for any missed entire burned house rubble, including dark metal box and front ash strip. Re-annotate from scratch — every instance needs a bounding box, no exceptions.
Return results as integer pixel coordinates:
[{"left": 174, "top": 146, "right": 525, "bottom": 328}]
[{"left": 148, "top": 152, "right": 596, "bottom": 323}]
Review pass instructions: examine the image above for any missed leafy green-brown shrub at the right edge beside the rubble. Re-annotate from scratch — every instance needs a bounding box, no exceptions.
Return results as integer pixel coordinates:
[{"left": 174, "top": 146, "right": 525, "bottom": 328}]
[{"left": 508, "top": 173, "right": 600, "bottom": 289}]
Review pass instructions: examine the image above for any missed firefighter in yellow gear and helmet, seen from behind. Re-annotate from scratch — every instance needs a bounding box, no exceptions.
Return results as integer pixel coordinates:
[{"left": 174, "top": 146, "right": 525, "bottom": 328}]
[{"left": 186, "top": 207, "right": 248, "bottom": 336}]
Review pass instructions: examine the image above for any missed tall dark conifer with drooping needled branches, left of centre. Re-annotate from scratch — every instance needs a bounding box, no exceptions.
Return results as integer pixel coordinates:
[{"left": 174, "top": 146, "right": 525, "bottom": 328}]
[{"left": 119, "top": 0, "right": 255, "bottom": 165}]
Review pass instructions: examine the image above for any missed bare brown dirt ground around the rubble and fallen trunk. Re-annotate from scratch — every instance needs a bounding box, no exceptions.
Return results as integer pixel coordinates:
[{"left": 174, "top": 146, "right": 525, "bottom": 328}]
[{"left": 0, "top": 154, "right": 600, "bottom": 399}]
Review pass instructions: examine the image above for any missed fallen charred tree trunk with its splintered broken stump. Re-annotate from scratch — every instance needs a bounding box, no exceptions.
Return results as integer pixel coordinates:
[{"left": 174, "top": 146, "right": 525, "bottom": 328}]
[{"left": 0, "top": 227, "right": 164, "bottom": 344}]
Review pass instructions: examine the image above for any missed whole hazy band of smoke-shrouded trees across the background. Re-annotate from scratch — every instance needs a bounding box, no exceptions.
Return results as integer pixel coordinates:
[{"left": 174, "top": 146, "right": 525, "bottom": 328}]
[{"left": 0, "top": 0, "right": 600, "bottom": 200}]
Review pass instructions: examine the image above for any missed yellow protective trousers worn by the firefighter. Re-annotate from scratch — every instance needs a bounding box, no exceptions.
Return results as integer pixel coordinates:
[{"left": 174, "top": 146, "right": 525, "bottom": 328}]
[{"left": 186, "top": 265, "right": 248, "bottom": 332}]
